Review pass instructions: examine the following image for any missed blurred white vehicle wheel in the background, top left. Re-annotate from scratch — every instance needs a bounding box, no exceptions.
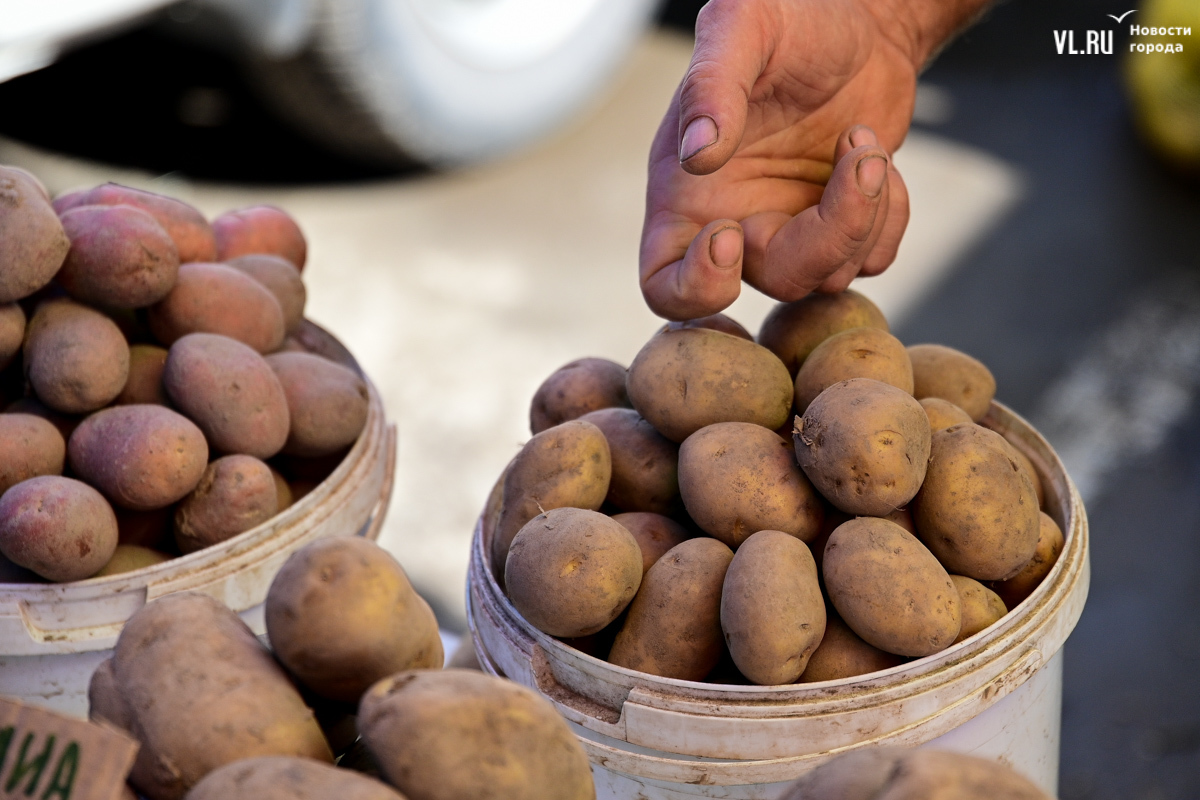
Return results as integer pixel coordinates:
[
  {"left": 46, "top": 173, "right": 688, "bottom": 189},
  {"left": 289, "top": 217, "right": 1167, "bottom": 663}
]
[{"left": 240, "top": 0, "right": 659, "bottom": 167}]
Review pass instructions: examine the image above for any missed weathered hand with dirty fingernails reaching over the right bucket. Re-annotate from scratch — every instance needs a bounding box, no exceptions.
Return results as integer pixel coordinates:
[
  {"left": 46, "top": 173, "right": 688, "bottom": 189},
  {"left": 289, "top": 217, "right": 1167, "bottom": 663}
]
[{"left": 641, "top": 0, "right": 931, "bottom": 319}]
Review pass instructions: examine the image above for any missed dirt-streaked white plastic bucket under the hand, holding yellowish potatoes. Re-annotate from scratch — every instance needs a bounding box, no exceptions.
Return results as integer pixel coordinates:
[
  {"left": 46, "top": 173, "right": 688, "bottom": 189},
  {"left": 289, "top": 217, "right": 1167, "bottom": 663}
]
[{"left": 467, "top": 404, "right": 1090, "bottom": 800}]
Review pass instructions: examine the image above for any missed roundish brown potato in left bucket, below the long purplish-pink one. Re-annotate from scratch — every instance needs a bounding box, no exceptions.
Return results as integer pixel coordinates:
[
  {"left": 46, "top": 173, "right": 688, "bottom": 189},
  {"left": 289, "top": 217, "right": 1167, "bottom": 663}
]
[{"left": 24, "top": 300, "right": 130, "bottom": 414}]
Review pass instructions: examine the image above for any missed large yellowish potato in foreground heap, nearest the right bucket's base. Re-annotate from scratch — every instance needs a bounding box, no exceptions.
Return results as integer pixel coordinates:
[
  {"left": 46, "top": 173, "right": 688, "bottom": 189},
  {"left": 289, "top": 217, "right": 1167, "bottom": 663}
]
[{"left": 359, "top": 669, "right": 595, "bottom": 800}]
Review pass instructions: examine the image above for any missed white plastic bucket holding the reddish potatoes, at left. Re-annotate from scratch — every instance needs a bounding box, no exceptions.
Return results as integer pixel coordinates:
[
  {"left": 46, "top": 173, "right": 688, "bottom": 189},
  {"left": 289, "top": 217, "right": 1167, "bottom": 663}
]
[{"left": 0, "top": 380, "right": 396, "bottom": 716}]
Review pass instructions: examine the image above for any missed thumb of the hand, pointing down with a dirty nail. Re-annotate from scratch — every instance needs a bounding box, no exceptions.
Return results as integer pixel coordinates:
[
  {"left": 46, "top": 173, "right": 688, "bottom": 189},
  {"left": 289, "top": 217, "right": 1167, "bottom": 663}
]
[{"left": 678, "top": 0, "right": 772, "bottom": 175}]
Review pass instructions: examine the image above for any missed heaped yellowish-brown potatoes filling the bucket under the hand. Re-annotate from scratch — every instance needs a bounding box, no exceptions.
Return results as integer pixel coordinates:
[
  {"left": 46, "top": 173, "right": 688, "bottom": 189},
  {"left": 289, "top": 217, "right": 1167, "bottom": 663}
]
[{"left": 484, "top": 291, "right": 1063, "bottom": 685}]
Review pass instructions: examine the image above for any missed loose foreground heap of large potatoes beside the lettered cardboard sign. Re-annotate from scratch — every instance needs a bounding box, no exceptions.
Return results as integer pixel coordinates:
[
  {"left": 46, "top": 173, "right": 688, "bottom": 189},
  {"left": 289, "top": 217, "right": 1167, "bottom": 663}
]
[{"left": 88, "top": 536, "right": 595, "bottom": 800}]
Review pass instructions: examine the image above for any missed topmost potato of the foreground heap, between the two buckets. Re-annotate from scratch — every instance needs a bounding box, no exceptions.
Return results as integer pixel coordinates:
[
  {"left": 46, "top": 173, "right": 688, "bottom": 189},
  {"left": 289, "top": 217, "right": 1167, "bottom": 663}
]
[{"left": 265, "top": 536, "right": 444, "bottom": 703}]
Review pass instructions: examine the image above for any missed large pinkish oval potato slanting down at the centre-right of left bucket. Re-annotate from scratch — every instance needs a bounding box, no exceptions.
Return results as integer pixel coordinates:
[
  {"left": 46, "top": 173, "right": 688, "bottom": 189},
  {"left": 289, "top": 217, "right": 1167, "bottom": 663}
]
[{"left": 162, "top": 333, "right": 292, "bottom": 458}]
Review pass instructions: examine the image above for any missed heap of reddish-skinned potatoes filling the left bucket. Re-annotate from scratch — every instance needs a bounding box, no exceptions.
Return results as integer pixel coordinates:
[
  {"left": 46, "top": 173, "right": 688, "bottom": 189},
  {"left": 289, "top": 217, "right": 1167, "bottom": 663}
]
[{"left": 0, "top": 167, "right": 368, "bottom": 583}]
